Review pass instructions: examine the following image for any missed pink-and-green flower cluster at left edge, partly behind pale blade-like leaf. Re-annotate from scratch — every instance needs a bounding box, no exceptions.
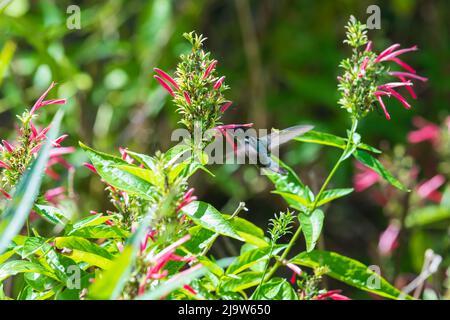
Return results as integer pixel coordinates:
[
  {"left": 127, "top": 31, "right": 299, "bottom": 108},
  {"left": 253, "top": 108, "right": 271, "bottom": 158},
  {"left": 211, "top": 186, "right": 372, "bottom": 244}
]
[{"left": 0, "top": 83, "right": 70, "bottom": 200}]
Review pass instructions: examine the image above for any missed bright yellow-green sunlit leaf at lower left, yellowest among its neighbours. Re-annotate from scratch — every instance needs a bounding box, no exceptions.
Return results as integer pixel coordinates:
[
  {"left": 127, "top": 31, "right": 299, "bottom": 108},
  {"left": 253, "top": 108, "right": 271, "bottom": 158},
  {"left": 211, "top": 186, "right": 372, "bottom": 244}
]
[{"left": 55, "top": 237, "right": 113, "bottom": 269}]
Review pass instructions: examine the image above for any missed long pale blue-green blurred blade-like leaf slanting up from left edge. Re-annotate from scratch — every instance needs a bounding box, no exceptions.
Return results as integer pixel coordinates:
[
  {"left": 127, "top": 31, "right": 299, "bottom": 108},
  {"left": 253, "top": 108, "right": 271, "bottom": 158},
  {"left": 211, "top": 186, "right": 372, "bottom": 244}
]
[{"left": 0, "top": 109, "right": 63, "bottom": 254}]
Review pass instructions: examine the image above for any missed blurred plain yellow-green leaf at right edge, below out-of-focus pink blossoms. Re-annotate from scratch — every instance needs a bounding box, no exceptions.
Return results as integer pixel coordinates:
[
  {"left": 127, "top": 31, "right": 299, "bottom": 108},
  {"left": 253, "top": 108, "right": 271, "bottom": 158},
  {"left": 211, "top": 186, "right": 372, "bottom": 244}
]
[{"left": 405, "top": 206, "right": 450, "bottom": 228}]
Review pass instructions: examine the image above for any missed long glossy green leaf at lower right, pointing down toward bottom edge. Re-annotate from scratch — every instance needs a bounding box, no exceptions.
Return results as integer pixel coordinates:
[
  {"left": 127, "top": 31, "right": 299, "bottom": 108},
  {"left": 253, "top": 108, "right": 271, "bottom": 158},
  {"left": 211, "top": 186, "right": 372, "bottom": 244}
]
[{"left": 291, "top": 250, "right": 410, "bottom": 299}]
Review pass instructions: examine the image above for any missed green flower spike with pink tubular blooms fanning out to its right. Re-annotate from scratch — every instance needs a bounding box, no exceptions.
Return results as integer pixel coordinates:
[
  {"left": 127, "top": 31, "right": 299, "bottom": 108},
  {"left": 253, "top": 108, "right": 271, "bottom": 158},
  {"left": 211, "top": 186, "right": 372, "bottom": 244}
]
[{"left": 338, "top": 17, "right": 428, "bottom": 120}]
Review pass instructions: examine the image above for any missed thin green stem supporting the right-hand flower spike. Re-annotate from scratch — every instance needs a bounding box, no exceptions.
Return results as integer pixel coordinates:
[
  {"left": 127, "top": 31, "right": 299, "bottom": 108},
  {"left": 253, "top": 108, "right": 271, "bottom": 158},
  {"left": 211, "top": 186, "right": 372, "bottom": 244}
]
[{"left": 264, "top": 118, "right": 358, "bottom": 281}]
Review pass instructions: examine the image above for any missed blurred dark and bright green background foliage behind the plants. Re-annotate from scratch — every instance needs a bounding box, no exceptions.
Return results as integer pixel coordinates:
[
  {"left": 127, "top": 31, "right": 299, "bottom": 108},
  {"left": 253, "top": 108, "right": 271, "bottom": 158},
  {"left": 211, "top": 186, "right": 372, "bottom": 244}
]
[{"left": 0, "top": 0, "right": 450, "bottom": 298}]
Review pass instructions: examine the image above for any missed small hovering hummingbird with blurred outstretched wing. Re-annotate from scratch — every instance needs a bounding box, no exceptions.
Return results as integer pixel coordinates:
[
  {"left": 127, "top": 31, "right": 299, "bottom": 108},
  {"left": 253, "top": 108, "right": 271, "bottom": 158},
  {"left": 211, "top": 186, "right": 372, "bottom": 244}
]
[{"left": 227, "top": 125, "right": 313, "bottom": 174}]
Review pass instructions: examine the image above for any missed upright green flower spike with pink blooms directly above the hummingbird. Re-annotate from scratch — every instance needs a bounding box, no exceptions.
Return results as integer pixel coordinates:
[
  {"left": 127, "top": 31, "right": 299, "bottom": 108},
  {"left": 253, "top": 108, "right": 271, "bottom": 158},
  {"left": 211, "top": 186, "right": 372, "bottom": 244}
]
[{"left": 154, "top": 32, "right": 232, "bottom": 132}]
